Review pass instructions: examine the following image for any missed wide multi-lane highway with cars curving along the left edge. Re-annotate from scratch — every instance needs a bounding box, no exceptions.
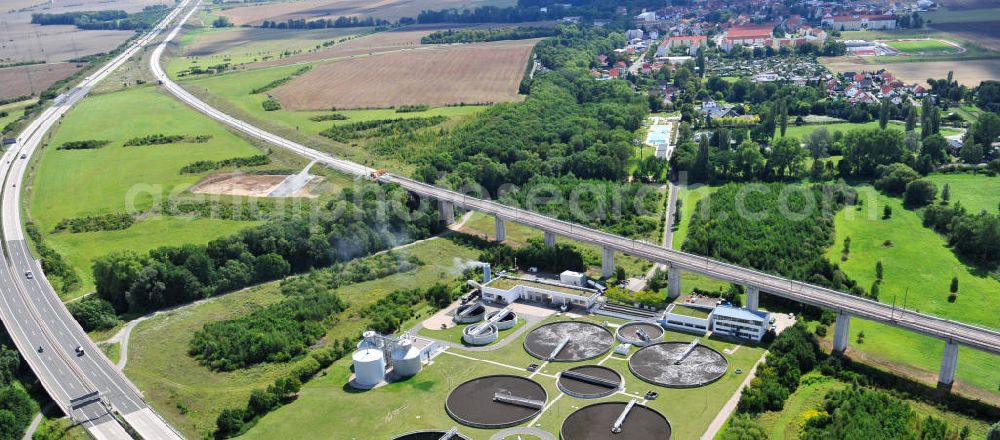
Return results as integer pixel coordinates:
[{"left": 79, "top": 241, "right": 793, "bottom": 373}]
[{"left": 0, "top": 0, "right": 191, "bottom": 440}]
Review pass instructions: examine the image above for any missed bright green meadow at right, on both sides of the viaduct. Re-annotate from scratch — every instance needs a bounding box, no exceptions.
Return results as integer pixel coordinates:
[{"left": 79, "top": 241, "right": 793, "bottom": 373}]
[{"left": 827, "top": 187, "right": 1000, "bottom": 396}]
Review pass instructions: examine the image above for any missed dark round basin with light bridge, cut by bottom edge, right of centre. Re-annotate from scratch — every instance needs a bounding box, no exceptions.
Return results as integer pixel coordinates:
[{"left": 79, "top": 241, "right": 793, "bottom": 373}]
[{"left": 559, "top": 402, "right": 671, "bottom": 440}]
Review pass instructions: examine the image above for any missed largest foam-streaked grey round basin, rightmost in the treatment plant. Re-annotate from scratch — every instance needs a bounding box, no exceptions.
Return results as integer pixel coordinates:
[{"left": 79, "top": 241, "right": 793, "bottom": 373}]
[{"left": 628, "top": 342, "right": 729, "bottom": 388}]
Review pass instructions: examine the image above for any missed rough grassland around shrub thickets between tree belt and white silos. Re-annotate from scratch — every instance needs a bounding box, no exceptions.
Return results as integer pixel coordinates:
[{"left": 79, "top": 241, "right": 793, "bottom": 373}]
[{"left": 125, "top": 238, "right": 478, "bottom": 438}]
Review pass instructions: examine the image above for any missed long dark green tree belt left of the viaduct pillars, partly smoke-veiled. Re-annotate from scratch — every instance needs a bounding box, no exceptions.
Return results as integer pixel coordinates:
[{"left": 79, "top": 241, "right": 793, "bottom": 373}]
[{"left": 93, "top": 183, "right": 441, "bottom": 313}]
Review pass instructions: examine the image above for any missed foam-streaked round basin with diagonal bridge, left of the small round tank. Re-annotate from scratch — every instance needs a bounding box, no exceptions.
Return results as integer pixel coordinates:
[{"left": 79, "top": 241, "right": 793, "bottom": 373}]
[{"left": 524, "top": 321, "right": 615, "bottom": 362}]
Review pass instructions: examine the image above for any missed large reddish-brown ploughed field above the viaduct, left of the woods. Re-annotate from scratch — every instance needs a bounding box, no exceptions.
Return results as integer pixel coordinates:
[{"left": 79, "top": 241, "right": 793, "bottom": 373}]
[{"left": 272, "top": 40, "right": 538, "bottom": 110}]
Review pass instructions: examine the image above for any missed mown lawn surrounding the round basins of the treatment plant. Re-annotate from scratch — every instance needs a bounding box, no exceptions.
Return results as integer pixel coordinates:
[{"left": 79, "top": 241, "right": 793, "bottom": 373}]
[{"left": 246, "top": 317, "right": 763, "bottom": 440}]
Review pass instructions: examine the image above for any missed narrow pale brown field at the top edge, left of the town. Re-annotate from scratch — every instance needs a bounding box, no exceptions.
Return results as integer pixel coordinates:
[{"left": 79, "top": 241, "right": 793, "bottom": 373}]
[{"left": 218, "top": 0, "right": 515, "bottom": 26}]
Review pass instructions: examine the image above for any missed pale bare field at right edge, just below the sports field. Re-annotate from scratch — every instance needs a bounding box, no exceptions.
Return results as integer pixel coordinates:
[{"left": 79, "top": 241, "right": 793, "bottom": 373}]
[{"left": 821, "top": 57, "right": 1000, "bottom": 87}]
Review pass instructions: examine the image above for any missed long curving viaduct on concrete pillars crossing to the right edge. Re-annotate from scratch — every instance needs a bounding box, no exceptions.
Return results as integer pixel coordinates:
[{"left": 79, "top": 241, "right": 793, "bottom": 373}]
[{"left": 150, "top": 0, "right": 1000, "bottom": 387}]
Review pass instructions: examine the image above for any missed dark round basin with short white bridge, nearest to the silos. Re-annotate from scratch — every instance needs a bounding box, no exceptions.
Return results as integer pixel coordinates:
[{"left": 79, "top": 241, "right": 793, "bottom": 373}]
[{"left": 445, "top": 374, "right": 548, "bottom": 429}]
